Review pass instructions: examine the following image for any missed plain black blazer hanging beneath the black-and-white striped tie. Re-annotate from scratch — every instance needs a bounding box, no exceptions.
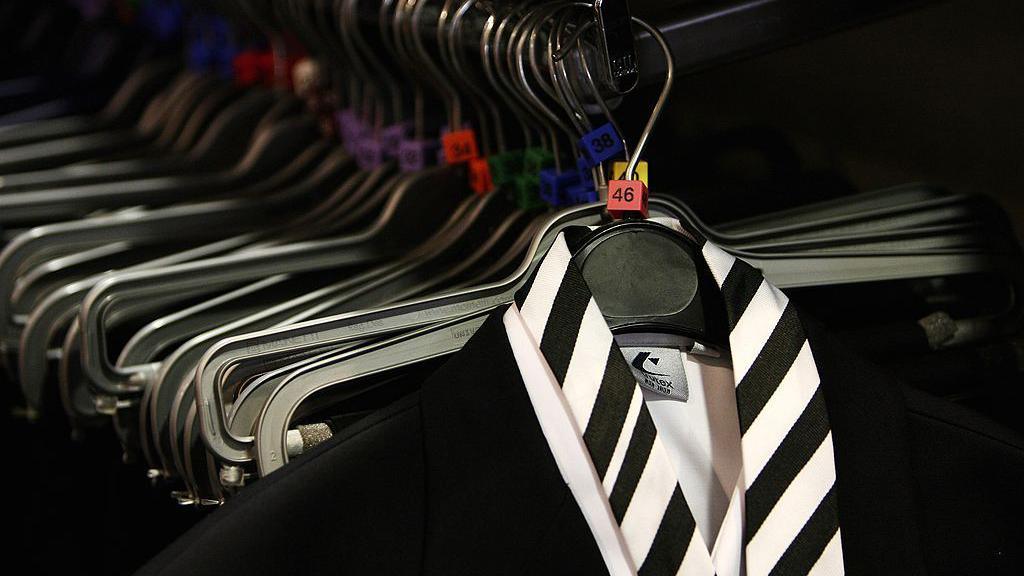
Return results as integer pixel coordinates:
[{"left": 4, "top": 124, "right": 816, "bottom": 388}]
[{"left": 141, "top": 311, "right": 1024, "bottom": 576}]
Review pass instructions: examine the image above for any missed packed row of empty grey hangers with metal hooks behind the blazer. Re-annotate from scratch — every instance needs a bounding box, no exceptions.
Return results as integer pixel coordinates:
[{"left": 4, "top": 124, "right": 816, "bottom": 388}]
[{"left": 0, "top": 0, "right": 1020, "bottom": 503}]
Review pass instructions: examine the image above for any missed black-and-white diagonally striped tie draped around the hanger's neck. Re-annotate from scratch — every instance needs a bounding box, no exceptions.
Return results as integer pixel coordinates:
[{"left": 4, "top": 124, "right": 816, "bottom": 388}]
[{"left": 516, "top": 229, "right": 843, "bottom": 576}]
